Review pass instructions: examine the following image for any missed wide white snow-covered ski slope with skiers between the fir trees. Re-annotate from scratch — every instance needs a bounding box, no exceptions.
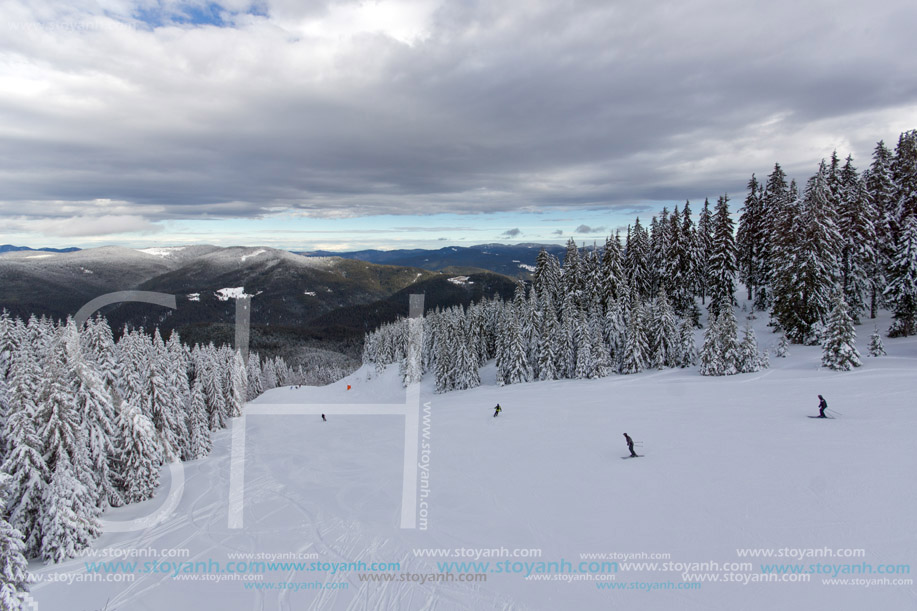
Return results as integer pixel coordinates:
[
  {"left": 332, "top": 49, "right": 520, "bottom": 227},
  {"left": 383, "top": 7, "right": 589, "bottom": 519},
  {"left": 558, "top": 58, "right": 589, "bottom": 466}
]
[{"left": 33, "top": 320, "right": 917, "bottom": 611}]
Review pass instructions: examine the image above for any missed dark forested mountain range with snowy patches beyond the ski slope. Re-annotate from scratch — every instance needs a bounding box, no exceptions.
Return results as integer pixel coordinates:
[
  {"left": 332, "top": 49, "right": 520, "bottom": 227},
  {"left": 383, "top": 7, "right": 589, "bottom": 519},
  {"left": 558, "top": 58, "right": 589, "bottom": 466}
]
[{"left": 0, "top": 245, "right": 524, "bottom": 368}]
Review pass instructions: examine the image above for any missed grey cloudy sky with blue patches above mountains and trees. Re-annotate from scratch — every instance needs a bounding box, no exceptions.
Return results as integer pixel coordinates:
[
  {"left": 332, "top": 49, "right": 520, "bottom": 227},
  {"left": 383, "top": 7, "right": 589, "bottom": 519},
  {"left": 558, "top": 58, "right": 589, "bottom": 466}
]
[{"left": 0, "top": 0, "right": 917, "bottom": 249}]
